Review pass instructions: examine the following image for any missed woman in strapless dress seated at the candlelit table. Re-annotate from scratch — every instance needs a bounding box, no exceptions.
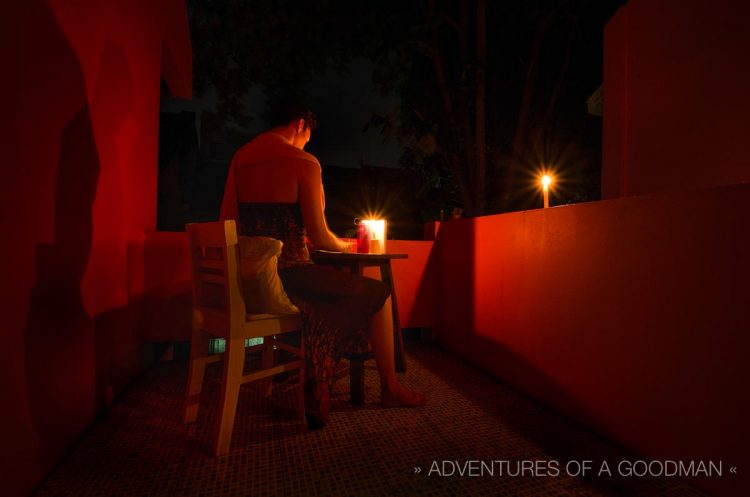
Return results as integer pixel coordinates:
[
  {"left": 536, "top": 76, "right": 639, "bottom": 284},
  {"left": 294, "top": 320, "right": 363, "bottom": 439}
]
[{"left": 221, "top": 100, "right": 425, "bottom": 428}]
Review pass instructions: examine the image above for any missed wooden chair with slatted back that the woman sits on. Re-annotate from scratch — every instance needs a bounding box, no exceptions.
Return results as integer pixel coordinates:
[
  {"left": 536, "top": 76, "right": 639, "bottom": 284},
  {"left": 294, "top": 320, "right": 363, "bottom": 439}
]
[{"left": 184, "top": 221, "right": 305, "bottom": 456}]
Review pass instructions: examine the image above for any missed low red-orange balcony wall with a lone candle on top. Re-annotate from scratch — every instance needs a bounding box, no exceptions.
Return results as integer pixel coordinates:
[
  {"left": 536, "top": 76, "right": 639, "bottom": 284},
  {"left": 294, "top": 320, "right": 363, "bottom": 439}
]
[{"left": 435, "top": 185, "right": 750, "bottom": 495}]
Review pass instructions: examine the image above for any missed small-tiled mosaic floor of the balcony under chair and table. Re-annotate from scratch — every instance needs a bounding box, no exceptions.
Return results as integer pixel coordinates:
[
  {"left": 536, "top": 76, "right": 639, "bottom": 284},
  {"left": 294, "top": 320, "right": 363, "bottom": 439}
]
[{"left": 35, "top": 343, "right": 704, "bottom": 497}]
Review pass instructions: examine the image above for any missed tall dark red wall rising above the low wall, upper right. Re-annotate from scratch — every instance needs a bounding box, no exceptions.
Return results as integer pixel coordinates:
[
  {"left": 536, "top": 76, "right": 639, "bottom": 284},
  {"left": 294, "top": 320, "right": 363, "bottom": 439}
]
[{"left": 602, "top": 0, "right": 750, "bottom": 198}]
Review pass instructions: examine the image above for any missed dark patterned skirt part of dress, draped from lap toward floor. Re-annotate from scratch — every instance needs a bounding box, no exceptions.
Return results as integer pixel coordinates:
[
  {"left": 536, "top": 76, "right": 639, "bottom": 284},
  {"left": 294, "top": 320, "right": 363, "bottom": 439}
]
[{"left": 279, "top": 264, "right": 390, "bottom": 429}]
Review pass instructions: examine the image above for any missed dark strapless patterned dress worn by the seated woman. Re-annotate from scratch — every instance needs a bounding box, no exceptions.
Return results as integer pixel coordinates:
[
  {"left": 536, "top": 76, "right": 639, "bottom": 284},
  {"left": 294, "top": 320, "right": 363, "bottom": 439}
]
[{"left": 238, "top": 203, "right": 390, "bottom": 429}]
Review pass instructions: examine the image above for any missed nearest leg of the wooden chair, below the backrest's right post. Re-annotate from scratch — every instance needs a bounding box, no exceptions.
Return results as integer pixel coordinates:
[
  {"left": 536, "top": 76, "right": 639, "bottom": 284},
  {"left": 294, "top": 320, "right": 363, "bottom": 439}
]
[{"left": 213, "top": 338, "right": 245, "bottom": 456}]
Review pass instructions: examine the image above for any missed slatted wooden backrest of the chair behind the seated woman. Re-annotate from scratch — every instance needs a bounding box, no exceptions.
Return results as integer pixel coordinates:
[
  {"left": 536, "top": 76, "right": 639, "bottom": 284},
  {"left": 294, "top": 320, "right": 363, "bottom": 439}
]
[{"left": 187, "top": 221, "right": 246, "bottom": 338}]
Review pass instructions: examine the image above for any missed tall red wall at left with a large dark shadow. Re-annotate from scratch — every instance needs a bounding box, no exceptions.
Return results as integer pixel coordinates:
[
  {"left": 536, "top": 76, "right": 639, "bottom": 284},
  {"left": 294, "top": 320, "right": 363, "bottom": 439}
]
[{"left": 0, "top": 0, "right": 192, "bottom": 496}]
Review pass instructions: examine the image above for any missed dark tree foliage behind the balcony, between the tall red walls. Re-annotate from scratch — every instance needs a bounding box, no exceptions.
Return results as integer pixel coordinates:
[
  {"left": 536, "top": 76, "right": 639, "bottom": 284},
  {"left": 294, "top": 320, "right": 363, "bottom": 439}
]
[{"left": 189, "top": 0, "right": 623, "bottom": 216}]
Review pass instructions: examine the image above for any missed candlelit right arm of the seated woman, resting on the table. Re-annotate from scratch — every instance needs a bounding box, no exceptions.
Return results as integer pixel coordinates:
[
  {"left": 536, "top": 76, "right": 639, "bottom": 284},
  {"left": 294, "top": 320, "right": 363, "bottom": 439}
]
[{"left": 299, "top": 164, "right": 351, "bottom": 252}]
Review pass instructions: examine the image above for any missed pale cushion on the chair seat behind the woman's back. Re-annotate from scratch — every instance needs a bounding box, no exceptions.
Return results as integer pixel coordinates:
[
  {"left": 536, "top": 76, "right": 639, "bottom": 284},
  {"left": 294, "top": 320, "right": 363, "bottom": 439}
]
[{"left": 239, "top": 236, "right": 299, "bottom": 314}]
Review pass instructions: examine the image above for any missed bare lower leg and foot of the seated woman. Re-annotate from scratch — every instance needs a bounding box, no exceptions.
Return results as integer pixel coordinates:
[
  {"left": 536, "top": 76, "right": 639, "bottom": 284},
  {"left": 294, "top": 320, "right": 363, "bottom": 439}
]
[{"left": 370, "top": 298, "right": 425, "bottom": 407}]
